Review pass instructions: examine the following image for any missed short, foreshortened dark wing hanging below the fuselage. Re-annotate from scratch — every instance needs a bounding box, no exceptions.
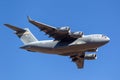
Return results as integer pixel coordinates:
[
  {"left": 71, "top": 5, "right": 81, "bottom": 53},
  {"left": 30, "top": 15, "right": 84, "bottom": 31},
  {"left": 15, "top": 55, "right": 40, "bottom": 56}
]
[{"left": 70, "top": 52, "right": 85, "bottom": 69}]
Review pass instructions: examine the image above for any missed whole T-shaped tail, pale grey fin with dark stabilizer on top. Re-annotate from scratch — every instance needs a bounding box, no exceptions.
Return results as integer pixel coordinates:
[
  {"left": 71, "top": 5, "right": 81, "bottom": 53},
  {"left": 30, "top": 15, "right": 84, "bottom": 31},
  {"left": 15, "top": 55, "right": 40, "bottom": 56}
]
[{"left": 4, "top": 24, "right": 38, "bottom": 44}]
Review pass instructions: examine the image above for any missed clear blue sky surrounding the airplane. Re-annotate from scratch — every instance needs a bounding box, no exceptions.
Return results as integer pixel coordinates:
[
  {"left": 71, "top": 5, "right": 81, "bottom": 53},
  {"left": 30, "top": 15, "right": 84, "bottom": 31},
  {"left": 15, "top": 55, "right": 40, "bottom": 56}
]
[{"left": 0, "top": 0, "right": 120, "bottom": 80}]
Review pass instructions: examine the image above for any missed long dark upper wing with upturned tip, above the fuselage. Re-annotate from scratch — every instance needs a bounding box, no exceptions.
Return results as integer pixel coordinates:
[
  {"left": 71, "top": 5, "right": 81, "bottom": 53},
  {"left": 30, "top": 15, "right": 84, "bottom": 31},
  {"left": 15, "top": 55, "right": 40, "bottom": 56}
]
[{"left": 28, "top": 17, "right": 75, "bottom": 40}]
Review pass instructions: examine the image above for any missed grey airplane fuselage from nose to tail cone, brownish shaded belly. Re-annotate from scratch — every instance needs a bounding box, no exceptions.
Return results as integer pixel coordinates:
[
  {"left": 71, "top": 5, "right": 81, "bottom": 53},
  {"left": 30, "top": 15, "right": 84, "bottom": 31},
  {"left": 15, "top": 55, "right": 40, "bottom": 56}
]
[{"left": 21, "top": 34, "right": 110, "bottom": 55}]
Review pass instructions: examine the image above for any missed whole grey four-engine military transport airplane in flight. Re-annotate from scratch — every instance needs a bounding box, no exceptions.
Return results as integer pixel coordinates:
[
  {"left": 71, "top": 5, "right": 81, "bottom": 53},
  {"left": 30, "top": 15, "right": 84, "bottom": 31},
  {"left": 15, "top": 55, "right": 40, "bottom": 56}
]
[{"left": 4, "top": 17, "right": 110, "bottom": 69}]
